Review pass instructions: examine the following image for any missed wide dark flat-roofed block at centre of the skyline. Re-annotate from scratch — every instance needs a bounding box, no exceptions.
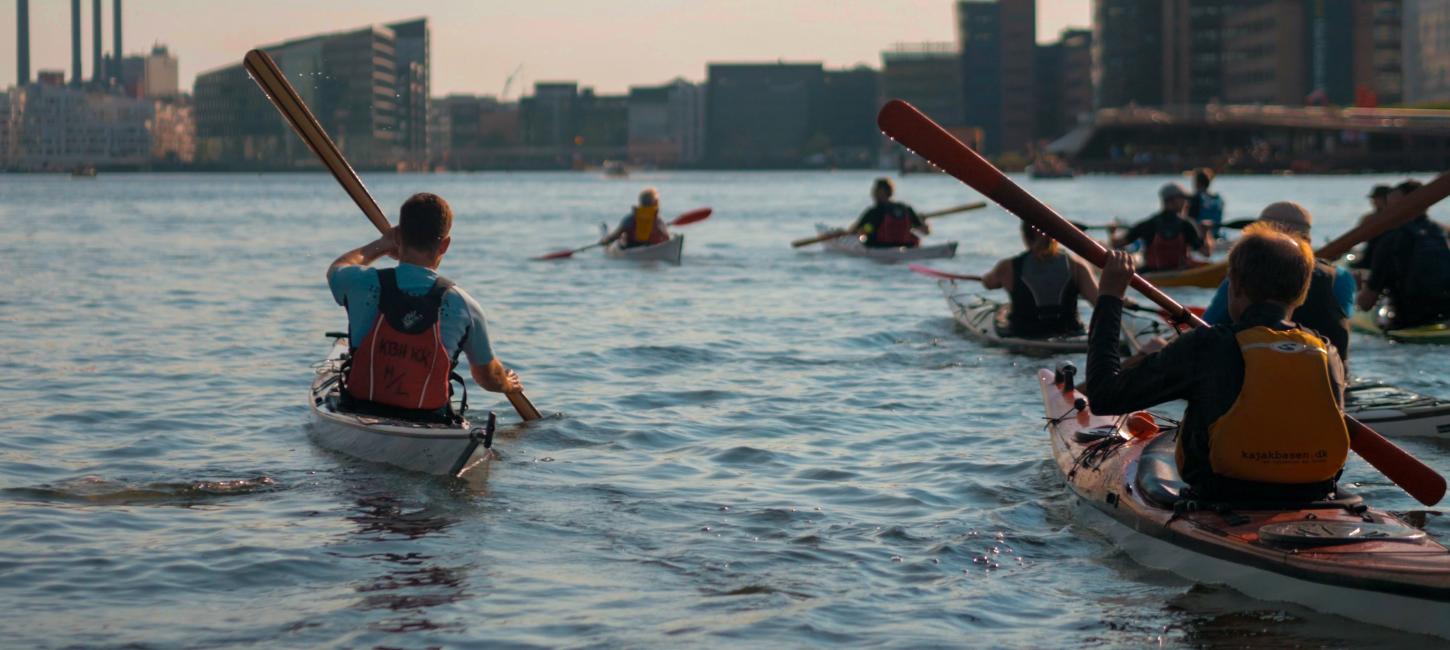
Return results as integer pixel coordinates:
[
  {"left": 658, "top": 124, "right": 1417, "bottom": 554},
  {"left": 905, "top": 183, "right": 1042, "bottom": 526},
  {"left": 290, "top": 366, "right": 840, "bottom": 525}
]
[{"left": 705, "top": 62, "right": 825, "bottom": 168}]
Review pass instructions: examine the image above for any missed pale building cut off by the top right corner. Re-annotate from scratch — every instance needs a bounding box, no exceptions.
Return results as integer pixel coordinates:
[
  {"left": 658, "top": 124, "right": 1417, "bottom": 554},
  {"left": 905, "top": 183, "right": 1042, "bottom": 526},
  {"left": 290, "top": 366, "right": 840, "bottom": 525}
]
[{"left": 1404, "top": 0, "right": 1450, "bottom": 104}]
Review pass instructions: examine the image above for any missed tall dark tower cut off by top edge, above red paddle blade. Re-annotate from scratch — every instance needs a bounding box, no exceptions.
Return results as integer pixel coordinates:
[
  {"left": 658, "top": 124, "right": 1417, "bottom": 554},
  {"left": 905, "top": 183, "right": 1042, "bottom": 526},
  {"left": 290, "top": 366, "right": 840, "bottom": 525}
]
[{"left": 957, "top": 0, "right": 1037, "bottom": 154}]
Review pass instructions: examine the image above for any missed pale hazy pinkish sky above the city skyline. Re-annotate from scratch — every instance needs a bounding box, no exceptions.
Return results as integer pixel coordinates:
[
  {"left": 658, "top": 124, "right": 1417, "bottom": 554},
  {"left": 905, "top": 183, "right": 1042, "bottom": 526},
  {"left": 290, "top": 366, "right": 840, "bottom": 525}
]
[{"left": 0, "top": 0, "right": 1092, "bottom": 97}]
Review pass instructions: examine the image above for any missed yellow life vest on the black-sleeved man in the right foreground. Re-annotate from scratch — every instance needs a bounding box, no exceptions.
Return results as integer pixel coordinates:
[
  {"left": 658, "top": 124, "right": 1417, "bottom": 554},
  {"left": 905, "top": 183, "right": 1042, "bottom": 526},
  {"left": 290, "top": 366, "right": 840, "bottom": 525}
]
[{"left": 1208, "top": 326, "right": 1350, "bottom": 483}]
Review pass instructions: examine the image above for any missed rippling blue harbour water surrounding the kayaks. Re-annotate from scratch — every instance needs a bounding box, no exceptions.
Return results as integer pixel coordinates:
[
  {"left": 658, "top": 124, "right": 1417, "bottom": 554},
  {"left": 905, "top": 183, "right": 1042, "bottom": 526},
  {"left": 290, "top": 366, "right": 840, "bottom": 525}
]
[{"left": 0, "top": 173, "right": 1450, "bottom": 647}]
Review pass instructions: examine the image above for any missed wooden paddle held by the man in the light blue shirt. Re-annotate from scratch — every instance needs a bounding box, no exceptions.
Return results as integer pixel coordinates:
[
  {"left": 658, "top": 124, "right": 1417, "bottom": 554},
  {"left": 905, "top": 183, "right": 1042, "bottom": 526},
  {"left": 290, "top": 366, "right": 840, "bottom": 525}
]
[{"left": 242, "top": 49, "right": 541, "bottom": 422}]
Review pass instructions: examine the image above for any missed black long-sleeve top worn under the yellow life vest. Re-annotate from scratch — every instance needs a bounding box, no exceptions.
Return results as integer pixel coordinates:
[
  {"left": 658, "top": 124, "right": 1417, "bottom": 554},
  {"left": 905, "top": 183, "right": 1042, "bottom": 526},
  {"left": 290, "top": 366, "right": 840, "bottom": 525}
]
[{"left": 1085, "top": 296, "right": 1344, "bottom": 485}]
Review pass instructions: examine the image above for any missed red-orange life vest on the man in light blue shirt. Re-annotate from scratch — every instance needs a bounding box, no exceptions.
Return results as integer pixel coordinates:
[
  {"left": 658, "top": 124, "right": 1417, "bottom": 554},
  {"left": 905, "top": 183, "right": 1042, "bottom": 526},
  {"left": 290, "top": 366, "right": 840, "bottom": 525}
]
[{"left": 345, "top": 268, "right": 452, "bottom": 411}]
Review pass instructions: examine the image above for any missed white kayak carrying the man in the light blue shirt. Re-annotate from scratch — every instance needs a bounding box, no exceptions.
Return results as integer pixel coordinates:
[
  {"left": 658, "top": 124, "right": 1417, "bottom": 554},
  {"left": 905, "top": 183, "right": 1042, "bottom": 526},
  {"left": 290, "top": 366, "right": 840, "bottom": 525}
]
[{"left": 307, "top": 337, "right": 493, "bottom": 476}]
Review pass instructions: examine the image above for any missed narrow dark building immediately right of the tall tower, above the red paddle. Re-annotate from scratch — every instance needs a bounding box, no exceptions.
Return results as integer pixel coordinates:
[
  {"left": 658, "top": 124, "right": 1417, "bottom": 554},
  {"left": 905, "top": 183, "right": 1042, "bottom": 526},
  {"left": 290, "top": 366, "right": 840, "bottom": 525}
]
[{"left": 1035, "top": 29, "right": 1092, "bottom": 141}]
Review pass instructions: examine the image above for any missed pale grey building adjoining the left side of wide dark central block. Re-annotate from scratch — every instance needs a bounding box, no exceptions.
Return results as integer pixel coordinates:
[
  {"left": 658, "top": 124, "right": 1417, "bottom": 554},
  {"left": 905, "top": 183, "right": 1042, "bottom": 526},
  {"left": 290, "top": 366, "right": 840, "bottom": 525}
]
[{"left": 628, "top": 78, "right": 705, "bottom": 167}]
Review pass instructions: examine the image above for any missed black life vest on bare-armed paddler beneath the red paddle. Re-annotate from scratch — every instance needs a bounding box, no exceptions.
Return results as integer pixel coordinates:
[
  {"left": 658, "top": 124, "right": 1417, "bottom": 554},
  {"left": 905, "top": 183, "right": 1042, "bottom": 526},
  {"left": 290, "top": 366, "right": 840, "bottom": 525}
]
[{"left": 1008, "top": 251, "right": 1083, "bottom": 338}]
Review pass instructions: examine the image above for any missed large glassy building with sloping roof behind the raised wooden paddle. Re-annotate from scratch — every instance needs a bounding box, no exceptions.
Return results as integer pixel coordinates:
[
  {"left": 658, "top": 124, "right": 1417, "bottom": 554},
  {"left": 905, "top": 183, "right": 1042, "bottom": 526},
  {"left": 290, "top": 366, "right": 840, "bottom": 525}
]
[{"left": 194, "top": 22, "right": 428, "bottom": 168}]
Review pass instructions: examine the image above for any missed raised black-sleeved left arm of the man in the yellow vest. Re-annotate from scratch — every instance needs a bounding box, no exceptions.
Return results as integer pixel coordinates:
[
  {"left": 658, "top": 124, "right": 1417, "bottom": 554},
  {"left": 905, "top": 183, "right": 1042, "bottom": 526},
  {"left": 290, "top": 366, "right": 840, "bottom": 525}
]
[{"left": 1085, "top": 251, "right": 1199, "bottom": 415}]
